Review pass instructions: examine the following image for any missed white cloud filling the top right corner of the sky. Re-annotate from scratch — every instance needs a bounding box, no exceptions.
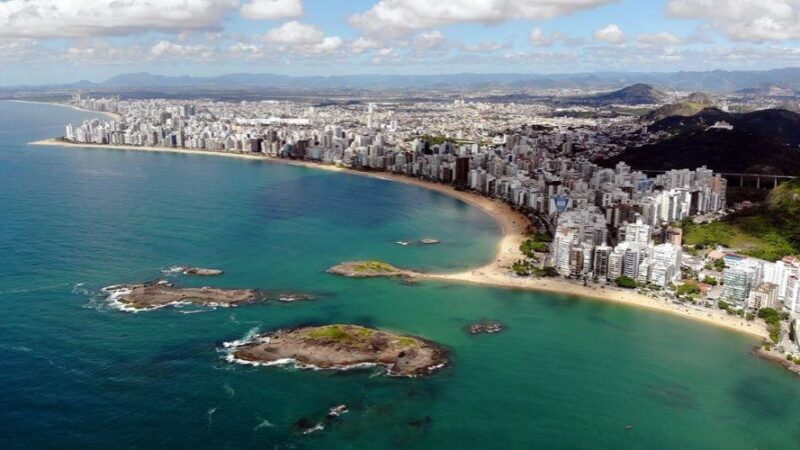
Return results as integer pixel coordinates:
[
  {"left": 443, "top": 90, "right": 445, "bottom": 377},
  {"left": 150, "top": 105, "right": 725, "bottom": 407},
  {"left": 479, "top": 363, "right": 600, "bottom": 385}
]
[{"left": 667, "top": 0, "right": 800, "bottom": 42}]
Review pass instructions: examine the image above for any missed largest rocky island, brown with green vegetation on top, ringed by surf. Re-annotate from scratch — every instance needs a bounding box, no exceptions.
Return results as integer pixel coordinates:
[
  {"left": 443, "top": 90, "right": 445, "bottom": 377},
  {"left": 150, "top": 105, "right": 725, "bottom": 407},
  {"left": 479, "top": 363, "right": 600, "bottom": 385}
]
[{"left": 225, "top": 325, "right": 448, "bottom": 377}]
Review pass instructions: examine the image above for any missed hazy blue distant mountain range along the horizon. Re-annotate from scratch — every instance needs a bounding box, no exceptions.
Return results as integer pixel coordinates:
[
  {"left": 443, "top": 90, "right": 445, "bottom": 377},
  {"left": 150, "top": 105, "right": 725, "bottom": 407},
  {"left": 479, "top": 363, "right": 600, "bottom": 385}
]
[{"left": 3, "top": 68, "right": 800, "bottom": 95}]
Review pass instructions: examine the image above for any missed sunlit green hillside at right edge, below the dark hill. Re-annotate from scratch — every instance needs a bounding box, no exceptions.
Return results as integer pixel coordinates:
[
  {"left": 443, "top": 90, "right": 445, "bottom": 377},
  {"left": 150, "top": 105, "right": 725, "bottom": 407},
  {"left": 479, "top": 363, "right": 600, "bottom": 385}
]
[{"left": 683, "top": 180, "right": 800, "bottom": 261}]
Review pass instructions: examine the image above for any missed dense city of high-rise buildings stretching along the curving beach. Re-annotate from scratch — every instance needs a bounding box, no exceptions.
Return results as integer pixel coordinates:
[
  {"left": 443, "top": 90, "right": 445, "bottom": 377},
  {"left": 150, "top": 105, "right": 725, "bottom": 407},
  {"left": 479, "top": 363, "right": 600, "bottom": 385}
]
[{"left": 66, "top": 98, "right": 727, "bottom": 294}]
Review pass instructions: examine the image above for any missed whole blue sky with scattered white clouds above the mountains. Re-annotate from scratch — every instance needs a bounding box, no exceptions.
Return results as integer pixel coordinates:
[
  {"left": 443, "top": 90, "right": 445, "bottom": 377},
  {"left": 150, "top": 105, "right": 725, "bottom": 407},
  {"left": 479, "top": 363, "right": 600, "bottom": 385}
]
[{"left": 0, "top": 0, "right": 800, "bottom": 86}]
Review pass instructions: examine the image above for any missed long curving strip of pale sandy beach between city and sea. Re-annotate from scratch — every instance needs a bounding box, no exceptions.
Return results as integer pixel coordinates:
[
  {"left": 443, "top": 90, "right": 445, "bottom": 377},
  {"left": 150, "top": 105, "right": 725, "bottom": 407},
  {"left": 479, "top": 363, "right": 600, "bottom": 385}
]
[{"left": 30, "top": 139, "right": 768, "bottom": 339}]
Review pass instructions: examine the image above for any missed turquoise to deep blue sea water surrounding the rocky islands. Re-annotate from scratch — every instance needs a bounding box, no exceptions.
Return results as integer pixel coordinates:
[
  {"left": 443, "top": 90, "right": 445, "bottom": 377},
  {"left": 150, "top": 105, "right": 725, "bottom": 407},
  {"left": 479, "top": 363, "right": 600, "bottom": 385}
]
[{"left": 0, "top": 102, "right": 800, "bottom": 449}]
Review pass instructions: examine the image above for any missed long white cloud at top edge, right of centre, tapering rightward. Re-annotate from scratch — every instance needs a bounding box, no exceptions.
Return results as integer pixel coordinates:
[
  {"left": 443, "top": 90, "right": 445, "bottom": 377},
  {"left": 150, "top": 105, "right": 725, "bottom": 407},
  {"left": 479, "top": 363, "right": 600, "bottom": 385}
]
[{"left": 350, "top": 0, "right": 617, "bottom": 35}]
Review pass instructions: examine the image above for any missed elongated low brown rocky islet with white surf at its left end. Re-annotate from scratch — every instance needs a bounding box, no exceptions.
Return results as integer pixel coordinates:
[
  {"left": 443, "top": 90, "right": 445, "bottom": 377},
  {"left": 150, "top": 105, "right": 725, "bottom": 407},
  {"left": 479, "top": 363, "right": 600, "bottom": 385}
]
[{"left": 103, "top": 280, "right": 261, "bottom": 310}]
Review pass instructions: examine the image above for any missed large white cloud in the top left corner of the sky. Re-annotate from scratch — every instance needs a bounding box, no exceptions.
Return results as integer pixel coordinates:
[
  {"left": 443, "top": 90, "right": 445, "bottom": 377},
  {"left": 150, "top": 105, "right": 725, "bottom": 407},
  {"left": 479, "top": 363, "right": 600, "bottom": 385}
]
[{"left": 0, "top": 0, "right": 239, "bottom": 38}]
